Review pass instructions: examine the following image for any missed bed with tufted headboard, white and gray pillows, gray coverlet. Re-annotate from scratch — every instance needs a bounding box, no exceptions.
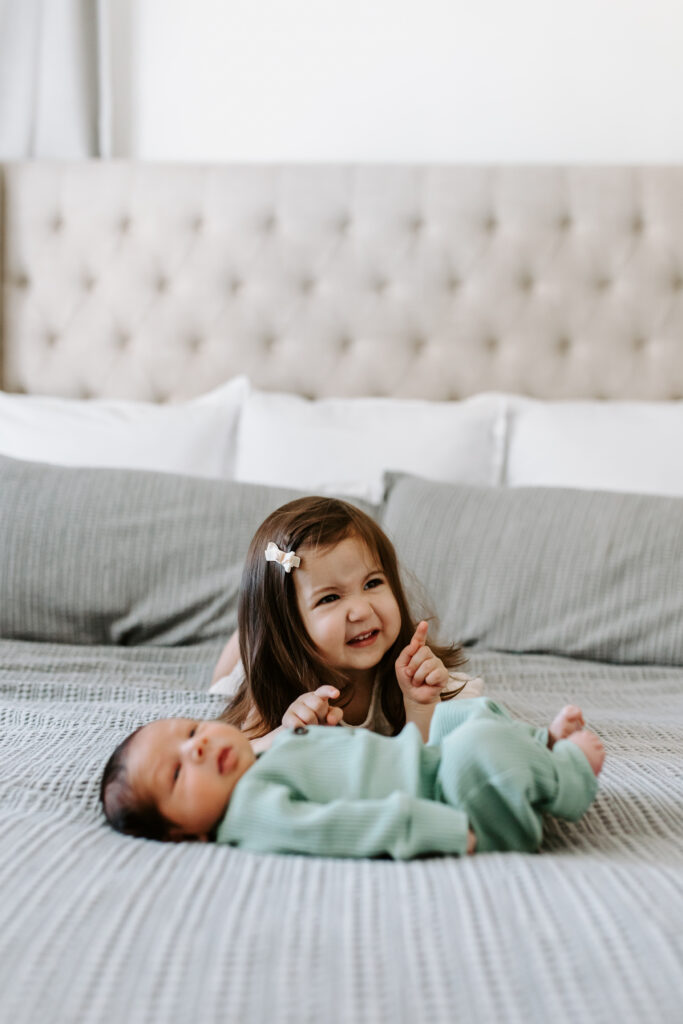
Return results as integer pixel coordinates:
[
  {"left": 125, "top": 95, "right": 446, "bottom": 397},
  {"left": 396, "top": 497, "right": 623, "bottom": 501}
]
[{"left": 0, "top": 162, "right": 683, "bottom": 1024}]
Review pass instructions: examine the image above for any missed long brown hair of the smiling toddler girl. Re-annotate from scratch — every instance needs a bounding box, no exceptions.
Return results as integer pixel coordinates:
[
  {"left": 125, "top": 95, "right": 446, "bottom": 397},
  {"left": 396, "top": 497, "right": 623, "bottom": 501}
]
[{"left": 221, "top": 498, "right": 465, "bottom": 737}]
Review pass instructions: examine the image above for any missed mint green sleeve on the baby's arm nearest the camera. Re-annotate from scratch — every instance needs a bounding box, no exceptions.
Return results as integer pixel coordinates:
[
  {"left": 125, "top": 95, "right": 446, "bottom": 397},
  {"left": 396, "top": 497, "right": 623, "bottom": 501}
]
[{"left": 216, "top": 781, "right": 468, "bottom": 860}]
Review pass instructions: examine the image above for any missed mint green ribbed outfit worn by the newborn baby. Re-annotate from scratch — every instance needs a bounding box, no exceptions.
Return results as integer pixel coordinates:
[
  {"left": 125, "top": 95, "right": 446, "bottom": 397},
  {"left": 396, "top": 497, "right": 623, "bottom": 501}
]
[{"left": 216, "top": 697, "right": 597, "bottom": 860}]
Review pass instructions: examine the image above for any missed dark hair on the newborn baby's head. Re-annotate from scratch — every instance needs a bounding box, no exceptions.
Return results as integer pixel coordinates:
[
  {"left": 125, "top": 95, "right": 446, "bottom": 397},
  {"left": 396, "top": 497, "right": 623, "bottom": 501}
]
[{"left": 99, "top": 725, "right": 172, "bottom": 842}]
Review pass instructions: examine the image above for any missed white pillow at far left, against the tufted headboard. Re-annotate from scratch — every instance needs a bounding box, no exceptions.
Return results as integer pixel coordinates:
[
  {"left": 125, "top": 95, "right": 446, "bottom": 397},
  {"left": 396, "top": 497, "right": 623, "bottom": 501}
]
[{"left": 0, "top": 377, "right": 249, "bottom": 478}]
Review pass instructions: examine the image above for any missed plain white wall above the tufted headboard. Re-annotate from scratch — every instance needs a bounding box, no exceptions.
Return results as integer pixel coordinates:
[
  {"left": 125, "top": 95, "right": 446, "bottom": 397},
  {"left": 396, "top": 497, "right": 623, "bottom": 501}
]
[{"left": 120, "top": 0, "right": 683, "bottom": 163}]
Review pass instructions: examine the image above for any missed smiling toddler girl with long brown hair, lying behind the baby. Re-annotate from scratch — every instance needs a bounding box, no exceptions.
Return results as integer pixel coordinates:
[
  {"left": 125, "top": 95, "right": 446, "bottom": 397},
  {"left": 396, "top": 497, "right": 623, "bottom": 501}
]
[{"left": 212, "top": 498, "right": 482, "bottom": 738}]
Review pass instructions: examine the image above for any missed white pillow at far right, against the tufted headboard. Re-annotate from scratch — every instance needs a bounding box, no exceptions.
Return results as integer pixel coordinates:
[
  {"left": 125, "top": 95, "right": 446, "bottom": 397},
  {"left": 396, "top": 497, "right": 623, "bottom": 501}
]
[{"left": 505, "top": 396, "right": 683, "bottom": 496}]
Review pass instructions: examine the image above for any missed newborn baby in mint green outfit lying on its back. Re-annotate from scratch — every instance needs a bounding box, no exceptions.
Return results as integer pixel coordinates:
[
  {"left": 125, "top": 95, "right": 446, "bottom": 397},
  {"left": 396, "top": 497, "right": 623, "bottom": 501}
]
[{"left": 100, "top": 693, "right": 604, "bottom": 859}]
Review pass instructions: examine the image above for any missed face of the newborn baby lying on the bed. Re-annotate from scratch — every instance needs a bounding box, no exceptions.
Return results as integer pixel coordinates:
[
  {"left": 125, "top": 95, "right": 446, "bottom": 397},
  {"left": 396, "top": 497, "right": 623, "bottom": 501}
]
[{"left": 127, "top": 718, "right": 256, "bottom": 840}]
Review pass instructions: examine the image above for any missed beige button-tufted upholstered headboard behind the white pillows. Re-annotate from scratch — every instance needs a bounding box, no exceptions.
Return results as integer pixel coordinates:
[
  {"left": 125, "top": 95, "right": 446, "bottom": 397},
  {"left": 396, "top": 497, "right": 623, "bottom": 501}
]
[{"left": 2, "top": 162, "right": 683, "bottom": 400}]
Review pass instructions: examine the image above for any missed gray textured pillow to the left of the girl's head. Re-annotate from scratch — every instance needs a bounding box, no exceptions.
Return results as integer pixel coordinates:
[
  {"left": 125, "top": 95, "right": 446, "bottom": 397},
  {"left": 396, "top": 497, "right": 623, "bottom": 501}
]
[{"left": 0, "top": 457, "right": 372, "bottom": 645}]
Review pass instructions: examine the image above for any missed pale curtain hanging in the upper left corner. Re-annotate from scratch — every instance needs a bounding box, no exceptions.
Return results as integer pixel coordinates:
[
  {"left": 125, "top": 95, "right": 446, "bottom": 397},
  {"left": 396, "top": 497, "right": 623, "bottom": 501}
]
[{"left": 0, "top": 0, "right": 111, "bottom": 160}]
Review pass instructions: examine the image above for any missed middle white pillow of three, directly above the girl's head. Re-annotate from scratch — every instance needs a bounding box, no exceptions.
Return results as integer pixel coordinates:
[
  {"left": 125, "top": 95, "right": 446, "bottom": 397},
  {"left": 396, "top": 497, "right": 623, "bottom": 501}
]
[{"left": 236, "top": 390, "right": 505, "bottom": 502}]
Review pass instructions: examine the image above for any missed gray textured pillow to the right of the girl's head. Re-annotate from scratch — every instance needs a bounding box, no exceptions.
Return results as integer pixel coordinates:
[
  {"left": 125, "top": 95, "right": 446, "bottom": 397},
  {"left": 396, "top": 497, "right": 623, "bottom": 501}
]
[{"left": 382, "top": 474, "right": 683, "bottom": 666}]
